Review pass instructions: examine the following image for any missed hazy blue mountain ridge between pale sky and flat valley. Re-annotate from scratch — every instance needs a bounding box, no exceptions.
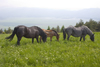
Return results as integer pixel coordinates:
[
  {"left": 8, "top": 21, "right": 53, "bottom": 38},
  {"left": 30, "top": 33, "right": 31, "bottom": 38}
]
[{"left": 0, "top": 8, "right": 100, "bottom": 20}]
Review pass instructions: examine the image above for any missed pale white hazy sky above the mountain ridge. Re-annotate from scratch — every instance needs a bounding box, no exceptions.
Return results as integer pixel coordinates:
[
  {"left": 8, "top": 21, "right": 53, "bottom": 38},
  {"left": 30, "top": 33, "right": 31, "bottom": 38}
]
[{"left": 0, "top": 0, "right": 100, "bottom": 10}]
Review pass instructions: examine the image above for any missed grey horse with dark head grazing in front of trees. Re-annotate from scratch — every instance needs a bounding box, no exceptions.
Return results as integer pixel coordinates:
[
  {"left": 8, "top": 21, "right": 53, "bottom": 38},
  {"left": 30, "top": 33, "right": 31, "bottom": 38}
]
[{"left": 63, "top": 25, "right": 94, "bottom": 41}]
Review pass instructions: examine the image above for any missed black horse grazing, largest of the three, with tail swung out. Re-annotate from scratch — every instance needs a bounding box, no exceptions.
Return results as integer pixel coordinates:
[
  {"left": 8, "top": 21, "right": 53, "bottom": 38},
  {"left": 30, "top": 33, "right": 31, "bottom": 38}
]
[{"left": 6, "top": 25, "right": 47, "bottom": 45}]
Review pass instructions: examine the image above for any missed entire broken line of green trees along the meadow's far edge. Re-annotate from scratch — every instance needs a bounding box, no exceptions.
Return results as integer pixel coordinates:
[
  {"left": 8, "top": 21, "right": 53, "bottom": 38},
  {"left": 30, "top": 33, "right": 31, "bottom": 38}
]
[{"left": 0, "top": 19, "right": 100, "bottom": 34}]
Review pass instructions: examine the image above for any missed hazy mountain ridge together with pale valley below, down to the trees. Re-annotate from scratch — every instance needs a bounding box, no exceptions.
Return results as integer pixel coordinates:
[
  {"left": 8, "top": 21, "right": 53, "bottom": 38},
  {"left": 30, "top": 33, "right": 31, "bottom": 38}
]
[{"left": 0, "top": 8, "right": 100, "bottom": 29}]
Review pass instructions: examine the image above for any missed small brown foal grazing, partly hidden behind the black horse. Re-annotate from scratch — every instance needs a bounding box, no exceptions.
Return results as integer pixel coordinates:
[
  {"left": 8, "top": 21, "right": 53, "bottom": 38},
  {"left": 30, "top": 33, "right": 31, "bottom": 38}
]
[{"left": 40, "top": 29, "right": 59, "bottom": 42}]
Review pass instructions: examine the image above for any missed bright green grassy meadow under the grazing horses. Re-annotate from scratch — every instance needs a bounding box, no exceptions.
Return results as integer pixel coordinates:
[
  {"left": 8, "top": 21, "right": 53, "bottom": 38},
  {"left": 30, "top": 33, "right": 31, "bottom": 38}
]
[{"left": 0, "top": 32, "right": 100, "bottom": 67}]
